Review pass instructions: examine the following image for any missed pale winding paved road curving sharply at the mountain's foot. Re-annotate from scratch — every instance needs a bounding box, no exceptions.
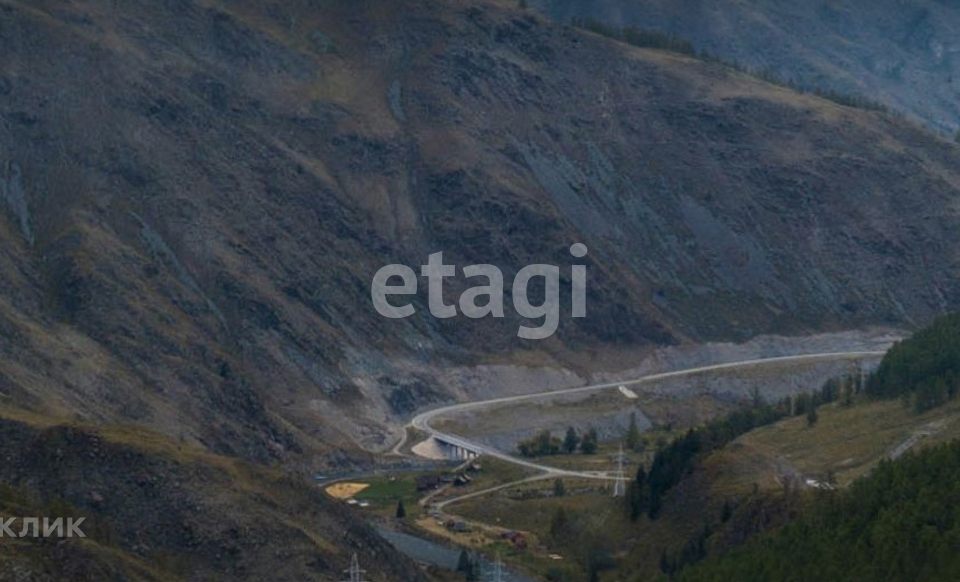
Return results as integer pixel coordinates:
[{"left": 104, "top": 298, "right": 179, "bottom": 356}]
[{"left": 404, "top": 351, "right": 886, "bottom": 484}]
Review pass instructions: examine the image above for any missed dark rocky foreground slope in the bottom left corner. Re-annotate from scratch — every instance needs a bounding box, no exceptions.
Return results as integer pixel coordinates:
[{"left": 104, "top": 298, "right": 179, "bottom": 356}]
[{"left": 0, "top": 416, "right": 425, "bottom": 582}]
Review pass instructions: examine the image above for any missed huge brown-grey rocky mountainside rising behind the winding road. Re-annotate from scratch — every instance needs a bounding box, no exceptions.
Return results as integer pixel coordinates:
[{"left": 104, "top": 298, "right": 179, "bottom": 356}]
[{"left": 0, "top": 0, "right": 960, "bottom": 465}]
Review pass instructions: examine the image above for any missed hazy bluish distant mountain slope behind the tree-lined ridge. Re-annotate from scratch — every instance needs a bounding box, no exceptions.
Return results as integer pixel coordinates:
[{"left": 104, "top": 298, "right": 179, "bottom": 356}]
[{"left": 530, "top": 0, "right": 960, "bottom": 134}]
